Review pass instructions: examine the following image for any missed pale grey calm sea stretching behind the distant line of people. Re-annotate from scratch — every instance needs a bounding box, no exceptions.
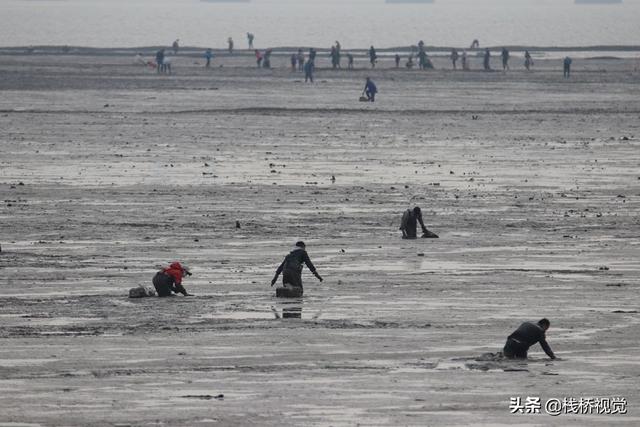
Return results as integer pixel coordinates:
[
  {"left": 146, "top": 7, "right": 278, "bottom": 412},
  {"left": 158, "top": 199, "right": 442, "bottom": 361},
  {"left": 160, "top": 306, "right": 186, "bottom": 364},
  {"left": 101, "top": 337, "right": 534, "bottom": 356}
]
[{"left": 0, "top": 0, "right": 640, "bottom": 49}]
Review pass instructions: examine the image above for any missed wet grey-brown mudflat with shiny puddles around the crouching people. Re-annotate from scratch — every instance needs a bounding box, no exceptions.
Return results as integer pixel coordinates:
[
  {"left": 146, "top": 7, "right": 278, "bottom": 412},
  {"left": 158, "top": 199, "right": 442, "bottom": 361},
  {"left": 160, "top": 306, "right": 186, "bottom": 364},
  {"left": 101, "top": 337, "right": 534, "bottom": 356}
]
[{"left": 0, "top": 56, "right": 640, "bottom": 426}]
